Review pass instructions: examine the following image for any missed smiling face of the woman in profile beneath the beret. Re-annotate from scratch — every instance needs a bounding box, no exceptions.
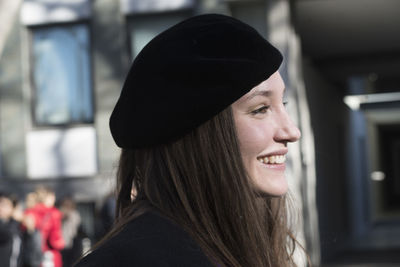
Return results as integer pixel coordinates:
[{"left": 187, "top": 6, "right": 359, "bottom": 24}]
[{"left": 232, "top": 72, "right": 300, "bottom": 196}]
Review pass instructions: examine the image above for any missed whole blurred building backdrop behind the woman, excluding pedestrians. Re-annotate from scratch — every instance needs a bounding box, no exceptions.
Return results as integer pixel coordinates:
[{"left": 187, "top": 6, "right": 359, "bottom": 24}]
[{"left": 0, "top": 0, "right": 400, "bottom": 266}]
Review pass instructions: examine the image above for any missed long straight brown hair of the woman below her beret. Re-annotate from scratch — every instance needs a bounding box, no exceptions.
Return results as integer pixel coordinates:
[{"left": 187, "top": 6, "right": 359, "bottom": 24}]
[{"left": 100, "top": 107, "right": 296, "bottom": 267}]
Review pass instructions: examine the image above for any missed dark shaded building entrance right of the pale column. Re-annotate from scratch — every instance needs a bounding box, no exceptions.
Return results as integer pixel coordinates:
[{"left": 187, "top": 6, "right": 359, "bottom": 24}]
[{"left": 293, "top": 0, "right": 400, "bottom": 266}]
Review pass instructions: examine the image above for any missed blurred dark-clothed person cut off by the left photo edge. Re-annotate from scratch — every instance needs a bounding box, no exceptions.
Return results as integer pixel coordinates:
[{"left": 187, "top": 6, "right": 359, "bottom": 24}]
[{"left": 0, "top": 192, "right": 21, "bottom": 267}]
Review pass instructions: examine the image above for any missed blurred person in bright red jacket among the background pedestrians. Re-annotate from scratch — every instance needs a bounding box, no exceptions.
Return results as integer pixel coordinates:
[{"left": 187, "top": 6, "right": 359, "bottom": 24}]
[{"left": 25, "top": 187, "right": 65, "bottom": 267}]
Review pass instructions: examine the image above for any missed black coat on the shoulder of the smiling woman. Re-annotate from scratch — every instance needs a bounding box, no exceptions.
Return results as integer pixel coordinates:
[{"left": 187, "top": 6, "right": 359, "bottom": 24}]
[{"left": 76, "top": 212, "right": 212, "bottom": 267}]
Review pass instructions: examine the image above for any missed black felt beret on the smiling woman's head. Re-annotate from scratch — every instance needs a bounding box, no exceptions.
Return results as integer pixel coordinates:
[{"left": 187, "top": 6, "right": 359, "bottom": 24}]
[{"left": 110, "top": 14, "right": 282, "bottom": 148}]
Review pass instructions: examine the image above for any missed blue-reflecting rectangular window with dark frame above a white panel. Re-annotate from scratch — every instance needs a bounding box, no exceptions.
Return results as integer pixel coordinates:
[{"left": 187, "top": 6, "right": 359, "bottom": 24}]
[{"left": 32, "top": 24, "right": 93, "bottom": 126}]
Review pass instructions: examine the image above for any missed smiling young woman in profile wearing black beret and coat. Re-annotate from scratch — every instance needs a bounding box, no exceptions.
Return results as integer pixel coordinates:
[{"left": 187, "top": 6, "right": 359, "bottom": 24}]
[{"left": 77, "top": 14, "right": 300, "bottom": 267}]
